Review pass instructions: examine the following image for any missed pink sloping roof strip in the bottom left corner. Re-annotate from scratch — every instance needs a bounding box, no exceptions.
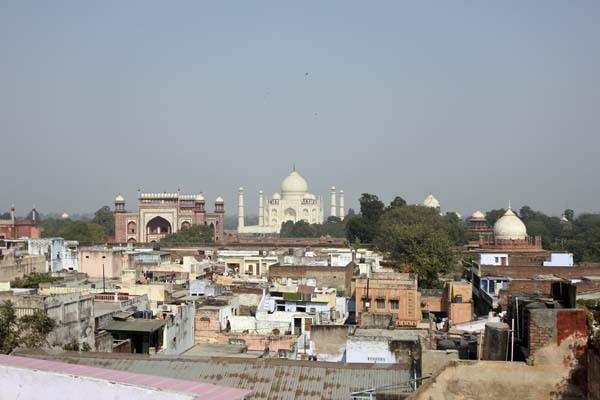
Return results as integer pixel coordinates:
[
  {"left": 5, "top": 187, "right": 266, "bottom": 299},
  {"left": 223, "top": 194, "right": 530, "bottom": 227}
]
[{"left": 0, "top": 354, "right": 249, "bottom": 400}]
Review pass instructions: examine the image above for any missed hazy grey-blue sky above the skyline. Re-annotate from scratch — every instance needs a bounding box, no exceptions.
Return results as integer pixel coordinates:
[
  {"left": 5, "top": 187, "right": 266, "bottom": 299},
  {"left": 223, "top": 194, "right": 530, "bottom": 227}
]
[{"left": 0, "top": 0, "right": 600, "bottom": 219}]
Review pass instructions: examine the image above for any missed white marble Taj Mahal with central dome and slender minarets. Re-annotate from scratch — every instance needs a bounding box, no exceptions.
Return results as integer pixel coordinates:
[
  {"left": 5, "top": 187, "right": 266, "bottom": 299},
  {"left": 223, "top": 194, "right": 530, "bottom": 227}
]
[{"left": 237, "top": 168, "right": 345, "bottom": 234}]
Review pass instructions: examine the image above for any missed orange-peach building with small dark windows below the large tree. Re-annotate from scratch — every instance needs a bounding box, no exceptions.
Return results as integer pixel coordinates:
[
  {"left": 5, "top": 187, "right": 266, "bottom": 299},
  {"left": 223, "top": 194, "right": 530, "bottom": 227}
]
[{"left": 355, "top": 272, "right": 422, "bottom": 326}]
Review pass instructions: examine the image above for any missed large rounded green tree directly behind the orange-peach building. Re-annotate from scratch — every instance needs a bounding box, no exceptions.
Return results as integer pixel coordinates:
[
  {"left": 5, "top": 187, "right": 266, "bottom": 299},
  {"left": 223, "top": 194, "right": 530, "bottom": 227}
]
[{"left": 375, "top": 205, "right": 457, "bottom": 288}]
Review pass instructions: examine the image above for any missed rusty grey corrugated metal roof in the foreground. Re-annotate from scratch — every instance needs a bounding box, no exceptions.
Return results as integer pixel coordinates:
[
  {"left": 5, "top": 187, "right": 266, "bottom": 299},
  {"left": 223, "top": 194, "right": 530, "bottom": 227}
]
[{"left": 17, "top": 351, "right": 411, "bottom": 400}]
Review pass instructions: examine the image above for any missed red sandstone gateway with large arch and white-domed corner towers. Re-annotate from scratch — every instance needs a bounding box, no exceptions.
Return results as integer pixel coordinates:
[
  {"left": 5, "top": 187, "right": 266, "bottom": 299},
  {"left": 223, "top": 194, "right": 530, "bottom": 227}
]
[{"left": 115, "top": 192, "right": 225, "bottom": 243}]
